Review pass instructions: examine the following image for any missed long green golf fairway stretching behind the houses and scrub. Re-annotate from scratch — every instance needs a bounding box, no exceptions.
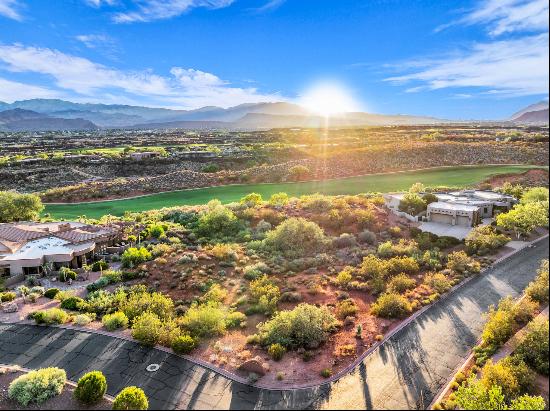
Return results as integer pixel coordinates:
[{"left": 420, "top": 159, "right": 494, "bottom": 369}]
[{"left": 44, "top": 165, "right": 536, "bottom": 219}]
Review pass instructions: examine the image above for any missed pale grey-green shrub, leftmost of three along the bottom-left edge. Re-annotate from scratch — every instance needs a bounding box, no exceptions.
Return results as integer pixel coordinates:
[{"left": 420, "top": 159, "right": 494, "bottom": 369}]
[{"left": 8, "top": 367, "right": 67, "bottom": 407}]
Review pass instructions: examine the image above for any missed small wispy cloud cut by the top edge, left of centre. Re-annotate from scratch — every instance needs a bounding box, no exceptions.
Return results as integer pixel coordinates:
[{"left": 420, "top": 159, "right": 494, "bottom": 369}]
[{"left": 108, "top": 0, "right": 235, "bottom": 23}]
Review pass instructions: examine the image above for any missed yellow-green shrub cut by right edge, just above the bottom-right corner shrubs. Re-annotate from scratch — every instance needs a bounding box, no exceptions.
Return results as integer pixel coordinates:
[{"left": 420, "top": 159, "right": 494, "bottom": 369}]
[{"left": 516, "top": 318, "right": 548, "bottom": 375}]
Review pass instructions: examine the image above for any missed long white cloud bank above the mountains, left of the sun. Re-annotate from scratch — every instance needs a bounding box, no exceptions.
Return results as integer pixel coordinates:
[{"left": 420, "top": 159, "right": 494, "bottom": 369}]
[{"left": 0, "top": 44, "right": 284, "bottom": 108}]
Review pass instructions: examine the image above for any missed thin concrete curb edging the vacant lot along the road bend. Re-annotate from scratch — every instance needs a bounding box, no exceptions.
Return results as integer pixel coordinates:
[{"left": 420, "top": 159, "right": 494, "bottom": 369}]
[{"left": 0, "top": 234, "right": 549, "bottom": 391}]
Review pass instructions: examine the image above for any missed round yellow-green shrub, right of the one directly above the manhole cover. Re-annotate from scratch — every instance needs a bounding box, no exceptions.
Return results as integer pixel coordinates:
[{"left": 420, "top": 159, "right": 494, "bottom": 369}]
[{"left": 180, "top": 303, "right": 227, "bottom": 338}]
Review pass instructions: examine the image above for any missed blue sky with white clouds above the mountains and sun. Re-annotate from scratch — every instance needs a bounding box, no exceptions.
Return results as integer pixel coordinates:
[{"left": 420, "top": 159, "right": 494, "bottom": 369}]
[{"left": 0, "top": 0, "right": 548, "bottom": 119}]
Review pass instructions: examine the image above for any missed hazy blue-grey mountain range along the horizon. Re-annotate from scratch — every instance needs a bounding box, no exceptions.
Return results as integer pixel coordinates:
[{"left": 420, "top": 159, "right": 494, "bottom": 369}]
[{"left": 0, "top": 99, "right": 548, "bottom": 131}]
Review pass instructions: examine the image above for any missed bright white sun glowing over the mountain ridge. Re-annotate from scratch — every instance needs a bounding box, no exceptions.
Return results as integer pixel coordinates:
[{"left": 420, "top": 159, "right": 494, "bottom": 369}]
[{"left": 299, "top": 82, "right": 359, "bottom": 117}]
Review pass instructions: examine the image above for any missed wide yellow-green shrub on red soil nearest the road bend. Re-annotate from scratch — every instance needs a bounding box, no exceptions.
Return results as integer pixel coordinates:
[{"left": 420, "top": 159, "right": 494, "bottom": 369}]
[{"left": 258, "top": 303, "right": 336, "bottom": 348}]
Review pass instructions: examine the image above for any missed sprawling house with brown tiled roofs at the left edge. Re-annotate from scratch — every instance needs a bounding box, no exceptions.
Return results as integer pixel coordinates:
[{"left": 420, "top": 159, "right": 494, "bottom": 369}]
[{"left": 0, "top": 222, "right": 119, "bottom": 276}]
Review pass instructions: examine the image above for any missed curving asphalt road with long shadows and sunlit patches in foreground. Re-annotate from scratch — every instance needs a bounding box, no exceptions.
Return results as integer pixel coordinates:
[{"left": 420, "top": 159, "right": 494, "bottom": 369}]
[{"left": 0, "top": 239, "right": 548, "bottom": 409}]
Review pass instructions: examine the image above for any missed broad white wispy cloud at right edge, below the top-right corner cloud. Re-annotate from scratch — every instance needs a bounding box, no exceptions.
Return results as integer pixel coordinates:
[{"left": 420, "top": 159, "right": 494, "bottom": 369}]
[{"left": 386, "top": 33, "right": 549, "bottom": 96}]
